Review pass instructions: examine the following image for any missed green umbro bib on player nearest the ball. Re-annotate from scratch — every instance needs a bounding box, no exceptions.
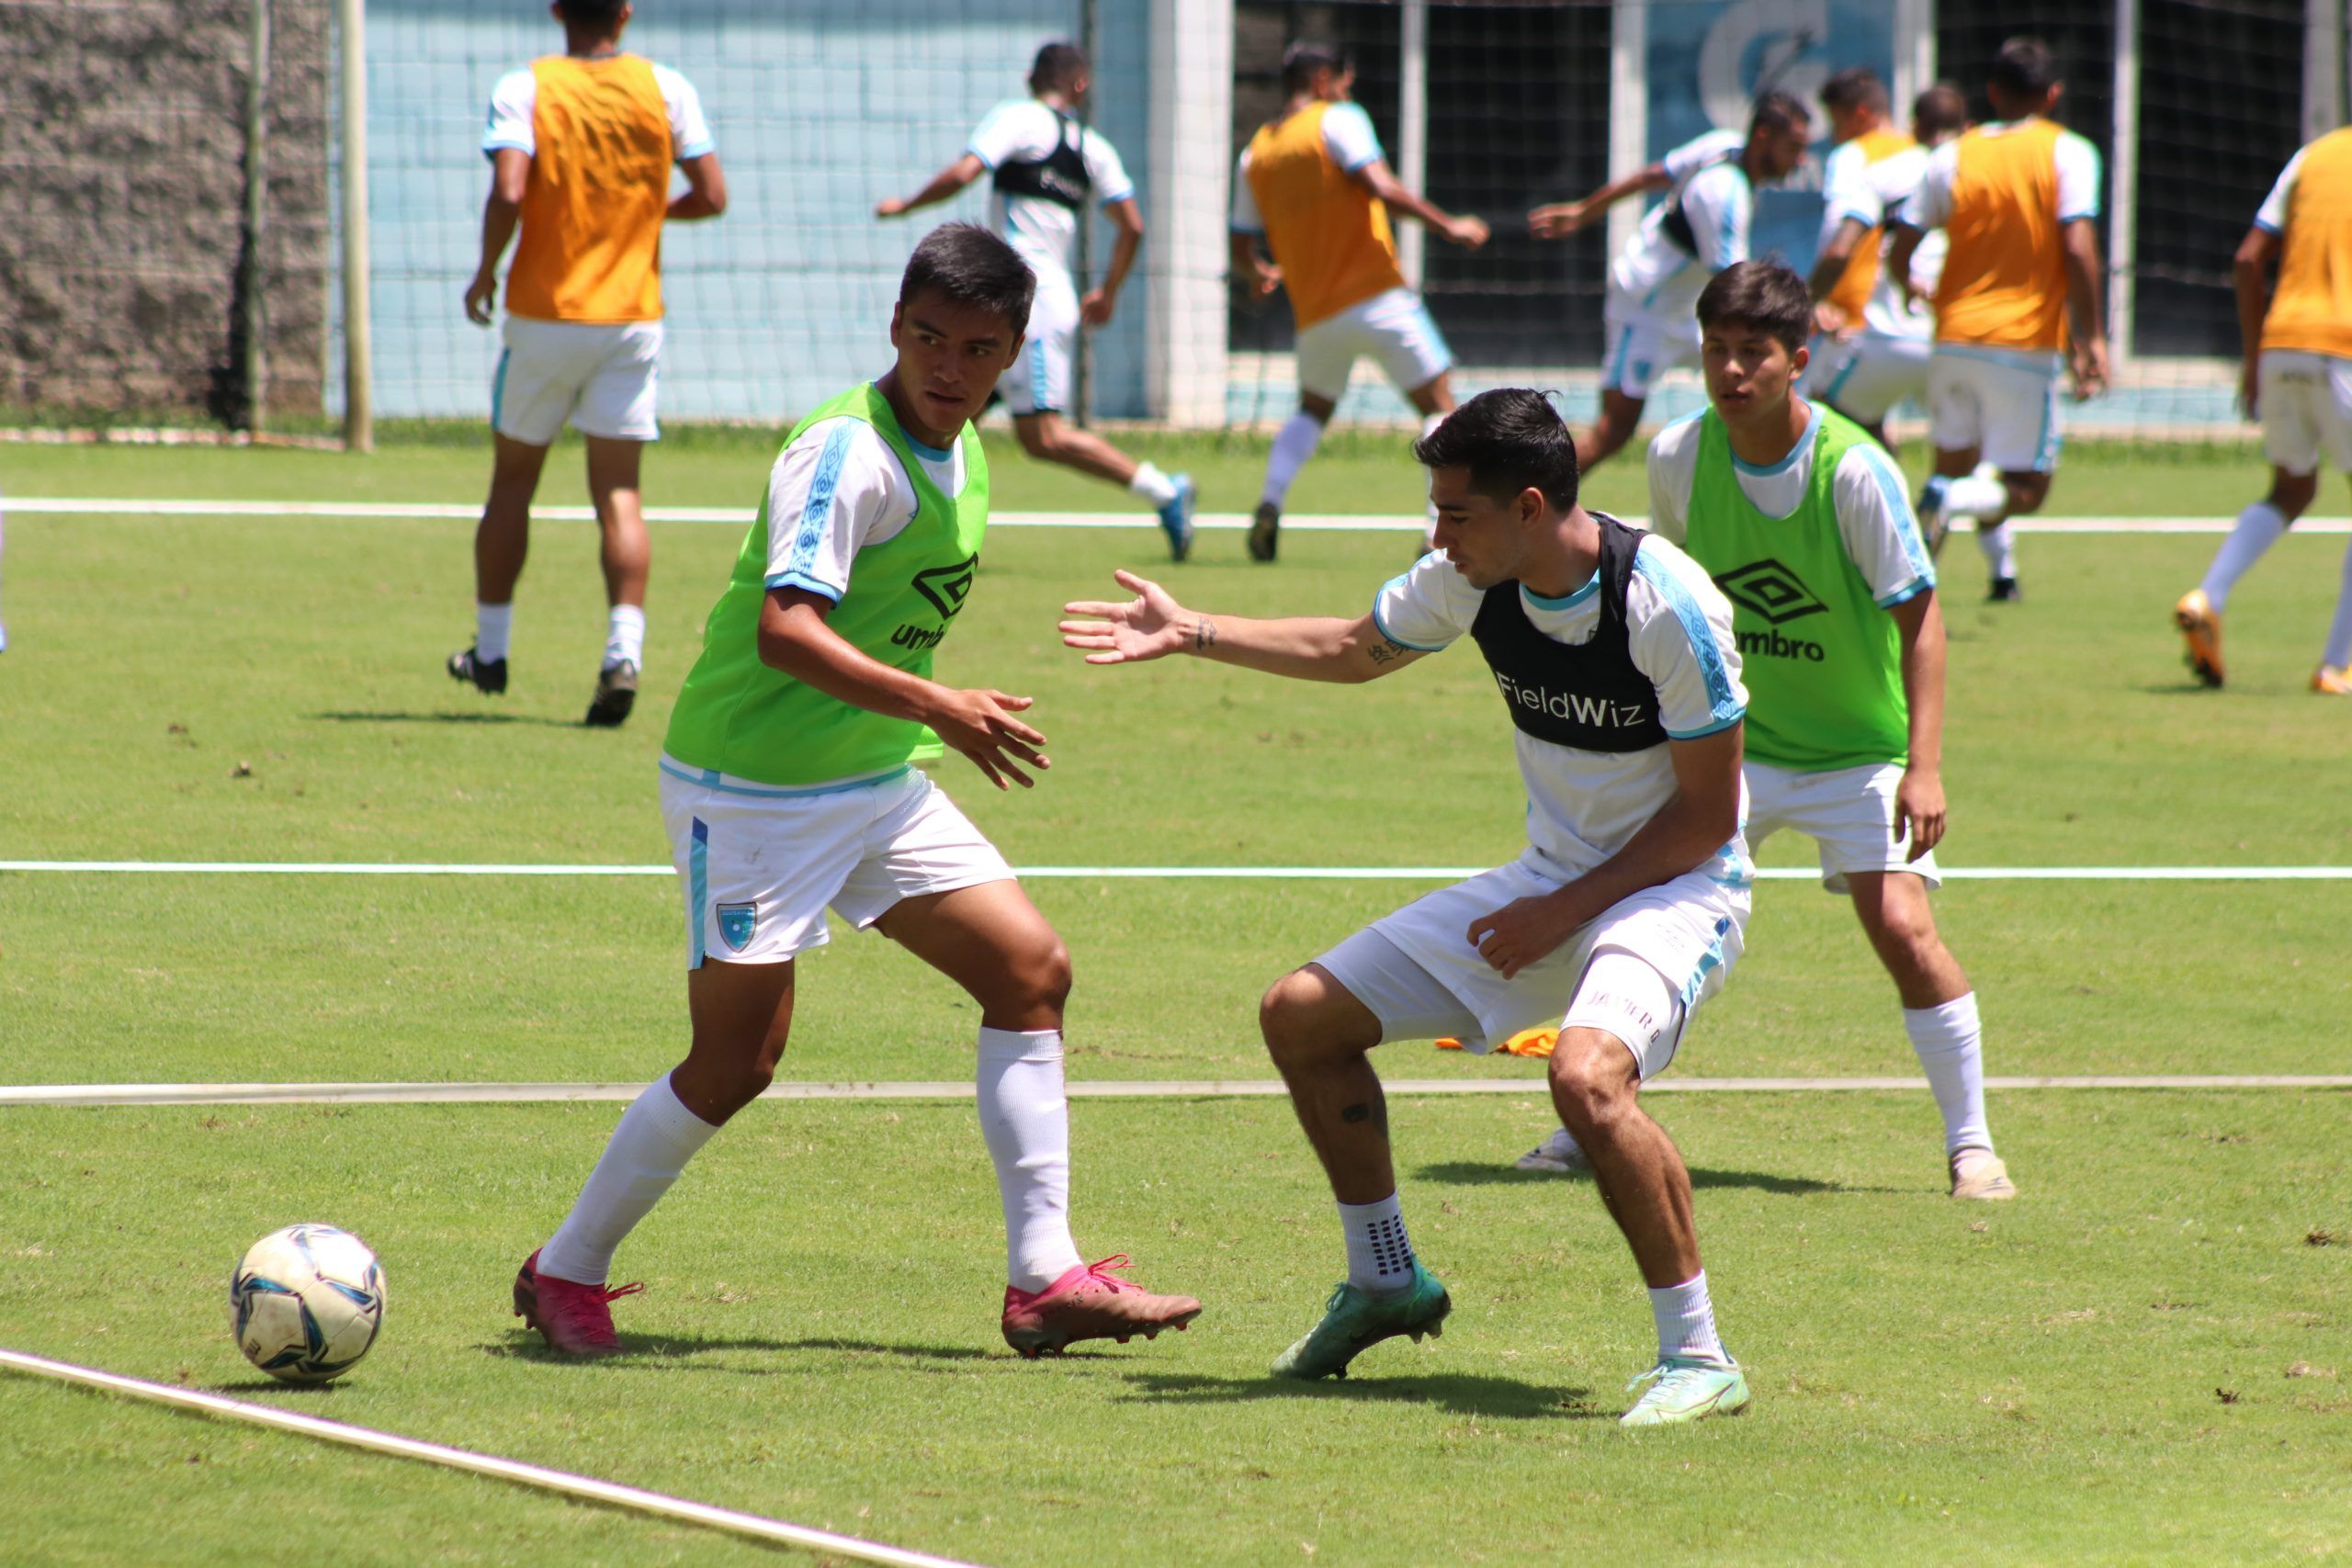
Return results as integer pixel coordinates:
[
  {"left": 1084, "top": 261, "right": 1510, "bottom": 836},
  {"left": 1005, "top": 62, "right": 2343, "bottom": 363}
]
[{"left": 663, "top": 381, "right": 988, "bottom": 787}]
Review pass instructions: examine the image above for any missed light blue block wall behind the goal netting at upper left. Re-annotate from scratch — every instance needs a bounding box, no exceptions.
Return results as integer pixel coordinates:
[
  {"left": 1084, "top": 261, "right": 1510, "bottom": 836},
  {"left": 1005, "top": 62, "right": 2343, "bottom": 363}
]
[{"left": 367, "top": 0, "right": 1150, "bottom": 421}]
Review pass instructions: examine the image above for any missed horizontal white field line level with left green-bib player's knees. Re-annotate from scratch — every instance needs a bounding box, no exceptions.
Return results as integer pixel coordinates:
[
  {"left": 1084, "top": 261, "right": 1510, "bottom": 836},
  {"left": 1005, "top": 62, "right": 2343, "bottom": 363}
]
[{"left": 0, "top": 1075, "right": 2352, "bottom": 1110}]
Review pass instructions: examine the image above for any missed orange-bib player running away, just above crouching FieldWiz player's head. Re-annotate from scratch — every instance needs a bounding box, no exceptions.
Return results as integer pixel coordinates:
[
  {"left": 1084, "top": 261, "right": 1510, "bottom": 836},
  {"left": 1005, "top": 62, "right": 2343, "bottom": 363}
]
[{"left": 1232, "top": 42, "right": 1487, "bottom": 562}]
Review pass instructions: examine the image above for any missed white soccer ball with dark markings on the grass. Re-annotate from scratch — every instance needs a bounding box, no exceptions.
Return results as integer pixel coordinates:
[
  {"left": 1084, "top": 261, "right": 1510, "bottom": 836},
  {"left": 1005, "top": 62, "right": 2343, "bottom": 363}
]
[{"left": 228, "top": 1224, "right": 383, "bottom": 1382}]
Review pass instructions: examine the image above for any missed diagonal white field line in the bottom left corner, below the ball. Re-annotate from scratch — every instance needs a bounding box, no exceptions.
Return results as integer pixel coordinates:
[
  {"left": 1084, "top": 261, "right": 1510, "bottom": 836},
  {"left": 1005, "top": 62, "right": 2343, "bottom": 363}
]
[{"left": 0, "top": 1349, "right": 971, "bottom": 1568}]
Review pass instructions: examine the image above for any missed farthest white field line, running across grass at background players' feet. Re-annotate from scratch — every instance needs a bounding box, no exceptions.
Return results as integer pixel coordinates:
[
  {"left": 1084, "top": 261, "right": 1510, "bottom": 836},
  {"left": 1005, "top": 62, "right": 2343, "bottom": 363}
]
[{"left": 7, "top": 496, "right": 2352, "bottom": 534}]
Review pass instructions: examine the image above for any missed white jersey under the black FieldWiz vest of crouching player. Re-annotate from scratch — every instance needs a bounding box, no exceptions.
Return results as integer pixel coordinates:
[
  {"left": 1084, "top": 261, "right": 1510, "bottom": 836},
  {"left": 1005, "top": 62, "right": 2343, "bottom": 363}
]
[{"left": 1371, "top": 536, "right": 1750, "bottom": 882}]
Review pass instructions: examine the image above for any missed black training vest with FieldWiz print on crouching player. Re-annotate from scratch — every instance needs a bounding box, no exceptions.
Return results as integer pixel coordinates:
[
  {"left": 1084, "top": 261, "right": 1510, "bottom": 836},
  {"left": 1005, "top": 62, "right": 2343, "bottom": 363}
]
[{"left": 1470, "top": 513, "right": 1665, "bottom": 752}]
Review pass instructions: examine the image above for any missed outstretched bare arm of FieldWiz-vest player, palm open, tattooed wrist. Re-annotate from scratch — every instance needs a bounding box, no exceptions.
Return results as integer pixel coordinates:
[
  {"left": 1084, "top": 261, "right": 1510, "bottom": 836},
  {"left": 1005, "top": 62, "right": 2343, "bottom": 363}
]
[{"left": 1061, "top": 571, "right": 1428, "bottom": 684}]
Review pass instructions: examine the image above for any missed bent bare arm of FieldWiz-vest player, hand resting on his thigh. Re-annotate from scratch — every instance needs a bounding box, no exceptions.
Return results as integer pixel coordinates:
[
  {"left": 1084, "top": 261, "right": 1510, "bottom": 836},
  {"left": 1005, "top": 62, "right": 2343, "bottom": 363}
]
[{"left": 1470, "top": 724, "right": 1746, "bottom": 980}]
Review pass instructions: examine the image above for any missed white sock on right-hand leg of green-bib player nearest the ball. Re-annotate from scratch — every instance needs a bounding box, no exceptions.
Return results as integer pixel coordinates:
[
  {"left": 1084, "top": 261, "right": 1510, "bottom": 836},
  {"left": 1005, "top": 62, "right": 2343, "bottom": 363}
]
[{"left": 978, "top": 1027, "right": 1082, "bottom": 1291}]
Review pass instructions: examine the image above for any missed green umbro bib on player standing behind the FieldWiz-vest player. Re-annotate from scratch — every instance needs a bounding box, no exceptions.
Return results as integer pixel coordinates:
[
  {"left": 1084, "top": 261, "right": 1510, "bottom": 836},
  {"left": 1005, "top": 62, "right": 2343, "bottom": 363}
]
[{"left": 1681, "top": 404, "right": 1910, "bottom": 773}]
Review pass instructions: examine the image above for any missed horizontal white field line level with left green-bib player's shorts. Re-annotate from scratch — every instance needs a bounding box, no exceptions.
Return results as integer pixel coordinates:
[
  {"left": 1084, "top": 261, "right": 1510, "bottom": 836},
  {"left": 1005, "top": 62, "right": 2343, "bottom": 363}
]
[{"left": 0, "top": 861, "right": 2352, "bottom": 882}]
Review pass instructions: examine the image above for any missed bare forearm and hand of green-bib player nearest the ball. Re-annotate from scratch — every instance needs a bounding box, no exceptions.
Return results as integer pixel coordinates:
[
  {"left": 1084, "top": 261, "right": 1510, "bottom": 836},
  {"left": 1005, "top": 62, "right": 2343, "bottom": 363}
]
[{"left": 760, "top": 588, "right": 1054, "bottom": 790}]
